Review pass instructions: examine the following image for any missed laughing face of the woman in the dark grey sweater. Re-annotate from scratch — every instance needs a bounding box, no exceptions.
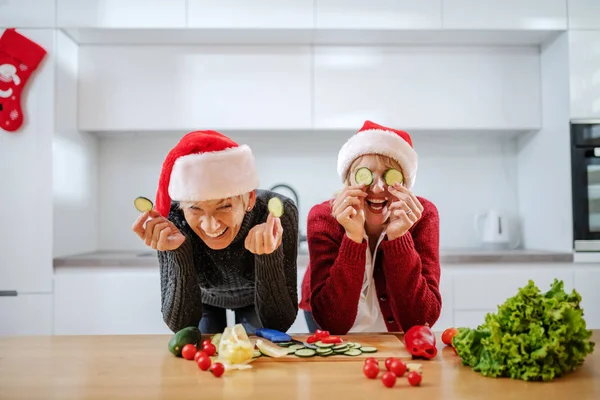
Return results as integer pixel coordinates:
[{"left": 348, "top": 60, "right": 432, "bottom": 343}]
[{"left": 179, "top": 191, "right": 256, "bottom": 250}]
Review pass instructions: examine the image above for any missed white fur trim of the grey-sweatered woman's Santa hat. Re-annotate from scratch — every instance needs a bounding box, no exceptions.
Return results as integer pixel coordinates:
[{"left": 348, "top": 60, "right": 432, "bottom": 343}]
[{"left": 169, "top": 145, "right": 258, "bottom": 201}]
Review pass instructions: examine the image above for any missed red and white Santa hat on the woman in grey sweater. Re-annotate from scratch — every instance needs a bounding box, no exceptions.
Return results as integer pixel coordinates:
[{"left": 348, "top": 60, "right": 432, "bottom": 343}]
[{"left": 156, "top": 131, "right": 258, "bottom": 217}]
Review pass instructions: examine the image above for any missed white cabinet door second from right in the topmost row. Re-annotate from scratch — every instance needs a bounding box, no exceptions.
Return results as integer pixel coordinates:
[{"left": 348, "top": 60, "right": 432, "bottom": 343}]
[{"left": 443, "top": 0, "right": 567, "bottom": 30}]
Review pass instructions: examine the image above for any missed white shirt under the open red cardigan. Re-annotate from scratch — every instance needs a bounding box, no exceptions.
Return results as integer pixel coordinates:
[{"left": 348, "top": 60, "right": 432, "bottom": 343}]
[{"left": 350, "top": 230, "right": 387, "bottom": 332}]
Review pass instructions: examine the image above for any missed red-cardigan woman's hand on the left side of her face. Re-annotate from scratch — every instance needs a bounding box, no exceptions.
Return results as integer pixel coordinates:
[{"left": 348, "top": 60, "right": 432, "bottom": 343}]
[{"left": 332, "top": 185, "right": 367, "bottom": 243}]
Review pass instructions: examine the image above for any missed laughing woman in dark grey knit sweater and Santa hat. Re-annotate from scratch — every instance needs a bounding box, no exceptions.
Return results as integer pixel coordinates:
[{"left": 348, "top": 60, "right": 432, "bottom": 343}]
[{"left": 133, "top": 131, "right": 298, "bottom": 333}]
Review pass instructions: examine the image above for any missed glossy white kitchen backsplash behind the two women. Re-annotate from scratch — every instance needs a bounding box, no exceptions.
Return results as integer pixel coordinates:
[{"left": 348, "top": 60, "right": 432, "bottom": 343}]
[{"left": 98, "top": 127, "right": 518, "bottom": 250}]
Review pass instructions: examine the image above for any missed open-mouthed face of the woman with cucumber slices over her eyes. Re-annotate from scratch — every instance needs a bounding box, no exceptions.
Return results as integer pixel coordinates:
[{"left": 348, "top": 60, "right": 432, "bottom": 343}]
[{"left": 346, "top": 154, "right": 402, "bottom": 227}]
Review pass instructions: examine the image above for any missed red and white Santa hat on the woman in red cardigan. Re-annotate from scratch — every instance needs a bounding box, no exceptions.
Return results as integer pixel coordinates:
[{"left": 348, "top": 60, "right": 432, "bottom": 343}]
[{"left": 337, "top": 121, "right": 418, "bottom": 189}]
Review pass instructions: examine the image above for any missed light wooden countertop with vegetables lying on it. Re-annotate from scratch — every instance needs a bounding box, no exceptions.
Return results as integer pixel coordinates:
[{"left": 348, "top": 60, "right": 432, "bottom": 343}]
[{"left": 0, "top": 331, "right": 600, "bottom": 400}]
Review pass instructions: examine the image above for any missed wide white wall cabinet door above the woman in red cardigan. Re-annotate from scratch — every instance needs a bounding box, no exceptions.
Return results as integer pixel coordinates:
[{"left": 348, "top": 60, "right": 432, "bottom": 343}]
[{"left": 314, "top": 46, "right": 541, "bottom": 130}]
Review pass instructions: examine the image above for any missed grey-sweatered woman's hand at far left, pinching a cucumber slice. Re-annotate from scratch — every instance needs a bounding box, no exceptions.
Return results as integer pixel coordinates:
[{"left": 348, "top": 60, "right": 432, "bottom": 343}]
[{"left": 131, "top": 210, "right": 185, "bottom": 251}]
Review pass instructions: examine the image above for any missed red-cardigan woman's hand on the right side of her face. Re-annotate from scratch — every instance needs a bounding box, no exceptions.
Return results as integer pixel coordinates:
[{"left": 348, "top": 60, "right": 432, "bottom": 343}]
[{"left": 386, "top": 183, "right": 423, "bottom": 240}]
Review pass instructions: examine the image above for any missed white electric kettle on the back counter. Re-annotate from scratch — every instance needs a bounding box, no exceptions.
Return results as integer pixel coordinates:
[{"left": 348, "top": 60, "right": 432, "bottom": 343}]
[{"left": 475, "top": 209, "right": 519, "bottom": 250}]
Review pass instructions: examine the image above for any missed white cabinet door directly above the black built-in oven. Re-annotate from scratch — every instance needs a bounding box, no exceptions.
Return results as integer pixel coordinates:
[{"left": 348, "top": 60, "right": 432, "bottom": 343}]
[{"left": 569, "top": 30, "right": 600, "bottom": 119}]
